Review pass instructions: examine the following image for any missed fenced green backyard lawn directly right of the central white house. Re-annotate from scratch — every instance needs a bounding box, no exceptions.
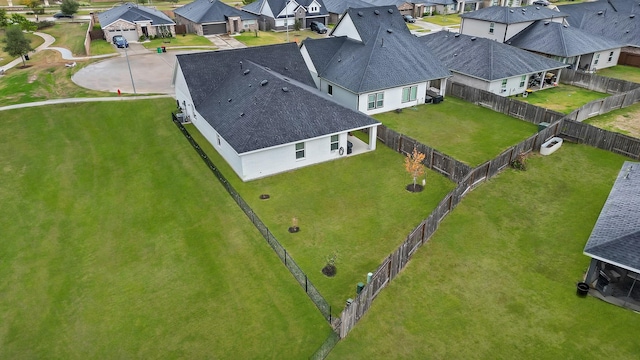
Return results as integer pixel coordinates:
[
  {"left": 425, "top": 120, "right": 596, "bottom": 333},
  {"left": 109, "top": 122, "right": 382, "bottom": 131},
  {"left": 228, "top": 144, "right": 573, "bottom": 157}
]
[{"left": 374, "top": 96, "right": 537, "bottom": 166}]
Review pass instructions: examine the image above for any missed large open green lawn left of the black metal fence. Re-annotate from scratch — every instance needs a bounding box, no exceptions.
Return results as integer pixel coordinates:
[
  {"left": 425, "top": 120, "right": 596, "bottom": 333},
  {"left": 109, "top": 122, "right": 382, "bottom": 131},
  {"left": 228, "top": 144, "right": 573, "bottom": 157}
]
[{"left": 0, "top": 99, "right": 330, "bottom": 359}]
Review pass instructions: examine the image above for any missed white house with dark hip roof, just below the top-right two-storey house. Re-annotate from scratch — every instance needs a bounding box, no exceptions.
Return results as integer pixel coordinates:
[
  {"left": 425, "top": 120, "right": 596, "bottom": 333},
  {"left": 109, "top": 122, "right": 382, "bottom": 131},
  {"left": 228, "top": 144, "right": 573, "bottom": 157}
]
[{"left": 507, "top": 20, "right": 623, "bottom": 71}]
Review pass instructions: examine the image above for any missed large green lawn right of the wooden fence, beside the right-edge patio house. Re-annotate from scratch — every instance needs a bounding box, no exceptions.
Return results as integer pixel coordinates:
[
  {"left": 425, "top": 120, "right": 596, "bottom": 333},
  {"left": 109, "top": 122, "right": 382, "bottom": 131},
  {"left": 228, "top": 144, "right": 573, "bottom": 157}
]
[{"left": 329, "top": 143, "right": 640, "bottom": 360}]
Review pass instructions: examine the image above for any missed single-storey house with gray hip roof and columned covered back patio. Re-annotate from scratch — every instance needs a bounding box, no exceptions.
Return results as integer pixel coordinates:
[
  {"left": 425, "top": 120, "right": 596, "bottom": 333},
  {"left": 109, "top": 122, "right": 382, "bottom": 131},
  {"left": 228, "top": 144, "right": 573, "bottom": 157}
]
[{"left": 418, "top": 31, "right": 567, "bottom": 96}]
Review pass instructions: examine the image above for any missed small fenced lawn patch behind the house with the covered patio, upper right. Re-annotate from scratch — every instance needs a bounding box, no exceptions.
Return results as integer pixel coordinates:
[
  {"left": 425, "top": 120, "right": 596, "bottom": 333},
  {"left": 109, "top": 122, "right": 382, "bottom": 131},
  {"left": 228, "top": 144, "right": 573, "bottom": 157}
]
[{"left": 517, "top": 84, "right": 610, "bottom": 114}]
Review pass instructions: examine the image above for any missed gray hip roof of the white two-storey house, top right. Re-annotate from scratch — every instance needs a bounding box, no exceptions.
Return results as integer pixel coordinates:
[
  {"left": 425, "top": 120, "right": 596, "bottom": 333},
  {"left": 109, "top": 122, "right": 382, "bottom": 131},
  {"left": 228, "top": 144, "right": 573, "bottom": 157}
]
[{"left": 460, "top": 6, "right": 567, "bottom": 24}]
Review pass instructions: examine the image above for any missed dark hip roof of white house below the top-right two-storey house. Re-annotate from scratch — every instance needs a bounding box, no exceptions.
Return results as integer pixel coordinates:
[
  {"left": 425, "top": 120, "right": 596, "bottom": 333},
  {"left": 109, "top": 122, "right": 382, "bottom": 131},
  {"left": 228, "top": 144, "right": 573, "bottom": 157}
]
[{"left": 507, "top": 21, "right": 624, "bottom": 57}]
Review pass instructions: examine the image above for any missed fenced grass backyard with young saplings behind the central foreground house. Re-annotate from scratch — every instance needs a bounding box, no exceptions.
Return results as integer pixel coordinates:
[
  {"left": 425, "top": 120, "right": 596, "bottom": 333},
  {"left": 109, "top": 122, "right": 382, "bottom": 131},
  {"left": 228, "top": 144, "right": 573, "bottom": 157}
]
[{"left": 190, "top": 127, "right": 454, "bottom": 314}]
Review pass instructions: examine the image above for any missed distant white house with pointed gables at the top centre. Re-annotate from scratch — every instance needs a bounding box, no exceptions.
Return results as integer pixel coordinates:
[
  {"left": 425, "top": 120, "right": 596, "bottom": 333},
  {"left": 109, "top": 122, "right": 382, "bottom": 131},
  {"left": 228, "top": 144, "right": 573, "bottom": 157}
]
[{"left": 242, "top": 0, "right": 329, "bottom": 30}]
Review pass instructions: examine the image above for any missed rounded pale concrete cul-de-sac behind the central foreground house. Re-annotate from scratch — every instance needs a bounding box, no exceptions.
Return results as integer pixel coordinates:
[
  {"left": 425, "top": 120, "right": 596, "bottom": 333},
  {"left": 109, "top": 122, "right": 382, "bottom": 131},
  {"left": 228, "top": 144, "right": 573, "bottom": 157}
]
[{"left": 71, "top": 43, "right": 184, "bottom": 95}]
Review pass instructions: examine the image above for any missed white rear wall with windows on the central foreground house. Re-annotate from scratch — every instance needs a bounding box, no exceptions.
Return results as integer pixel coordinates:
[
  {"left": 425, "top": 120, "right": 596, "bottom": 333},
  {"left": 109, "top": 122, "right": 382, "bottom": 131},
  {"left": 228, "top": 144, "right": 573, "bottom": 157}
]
[{"left": 240, "top": 132, "right": 347, "bottom": 181}]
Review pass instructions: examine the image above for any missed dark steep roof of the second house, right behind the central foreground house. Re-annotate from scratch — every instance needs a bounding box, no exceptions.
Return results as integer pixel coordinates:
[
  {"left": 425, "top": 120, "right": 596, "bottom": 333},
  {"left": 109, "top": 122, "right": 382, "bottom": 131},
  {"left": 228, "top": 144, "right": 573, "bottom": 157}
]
[{"left": 303, "top": 6, "right": 451, "bottom": 94}]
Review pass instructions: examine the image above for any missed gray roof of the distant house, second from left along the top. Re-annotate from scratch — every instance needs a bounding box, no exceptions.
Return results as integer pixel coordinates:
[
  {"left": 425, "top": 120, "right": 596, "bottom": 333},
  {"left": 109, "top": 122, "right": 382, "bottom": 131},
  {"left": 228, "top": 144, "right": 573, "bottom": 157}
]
[{"left": 173, "top": 0, "right": 258, "bottom": 24}]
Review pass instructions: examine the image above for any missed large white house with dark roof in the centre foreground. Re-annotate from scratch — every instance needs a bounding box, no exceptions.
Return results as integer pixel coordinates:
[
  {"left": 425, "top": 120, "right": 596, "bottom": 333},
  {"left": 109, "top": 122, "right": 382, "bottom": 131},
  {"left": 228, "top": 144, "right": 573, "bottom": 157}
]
[{"left": 173, "top": 43, "right": 379, "bottom": 181}]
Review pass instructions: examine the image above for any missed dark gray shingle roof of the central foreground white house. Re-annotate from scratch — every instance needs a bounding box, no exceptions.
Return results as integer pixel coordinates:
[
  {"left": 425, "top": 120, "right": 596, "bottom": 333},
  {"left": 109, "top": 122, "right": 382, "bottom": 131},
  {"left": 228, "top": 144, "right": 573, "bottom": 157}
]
[{"left": 177, "top": 43, "right": 379, "bottom": 154}]
